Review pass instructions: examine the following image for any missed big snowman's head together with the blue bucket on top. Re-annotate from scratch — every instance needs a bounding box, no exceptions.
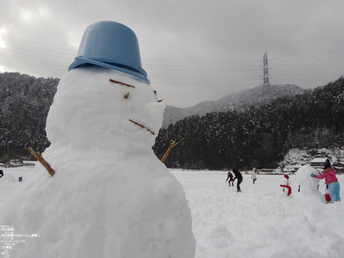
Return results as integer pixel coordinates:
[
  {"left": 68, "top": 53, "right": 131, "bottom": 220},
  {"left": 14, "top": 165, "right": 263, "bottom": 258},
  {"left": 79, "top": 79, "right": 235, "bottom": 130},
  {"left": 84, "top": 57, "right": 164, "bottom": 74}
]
[{"left": 46, "top": 21, "right": 165, "bottom": 154}]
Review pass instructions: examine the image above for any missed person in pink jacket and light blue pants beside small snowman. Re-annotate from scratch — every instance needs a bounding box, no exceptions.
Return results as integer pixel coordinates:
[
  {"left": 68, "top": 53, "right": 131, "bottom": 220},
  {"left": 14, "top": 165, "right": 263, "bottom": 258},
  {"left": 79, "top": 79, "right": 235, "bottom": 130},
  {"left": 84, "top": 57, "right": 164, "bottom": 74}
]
[{"left": 311, "top": 159, "right": 341, "bottom": 203}]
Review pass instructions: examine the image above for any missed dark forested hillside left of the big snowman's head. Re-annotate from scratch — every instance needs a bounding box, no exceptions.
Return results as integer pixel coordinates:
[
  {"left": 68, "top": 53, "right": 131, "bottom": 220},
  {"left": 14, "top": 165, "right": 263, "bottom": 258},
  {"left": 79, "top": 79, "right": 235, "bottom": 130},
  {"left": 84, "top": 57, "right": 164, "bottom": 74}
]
[{"left": 0, "top": 73, "right": 59, "bottom": 162}]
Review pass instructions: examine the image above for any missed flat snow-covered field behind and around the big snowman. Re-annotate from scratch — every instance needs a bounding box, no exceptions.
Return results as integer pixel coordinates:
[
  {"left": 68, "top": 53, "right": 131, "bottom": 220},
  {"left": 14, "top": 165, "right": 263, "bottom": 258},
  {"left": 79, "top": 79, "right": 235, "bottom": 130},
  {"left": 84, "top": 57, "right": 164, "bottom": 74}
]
[{"left": 0, "top": 167, "right": 344, "bottom": 258}]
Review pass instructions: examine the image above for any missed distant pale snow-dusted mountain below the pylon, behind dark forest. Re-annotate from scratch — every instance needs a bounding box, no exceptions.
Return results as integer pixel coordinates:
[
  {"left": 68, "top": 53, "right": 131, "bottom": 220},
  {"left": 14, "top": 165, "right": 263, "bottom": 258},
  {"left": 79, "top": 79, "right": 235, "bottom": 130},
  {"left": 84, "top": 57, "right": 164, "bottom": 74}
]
[{"left": 163, "top": 84, "right": 304, "bottom": 128}]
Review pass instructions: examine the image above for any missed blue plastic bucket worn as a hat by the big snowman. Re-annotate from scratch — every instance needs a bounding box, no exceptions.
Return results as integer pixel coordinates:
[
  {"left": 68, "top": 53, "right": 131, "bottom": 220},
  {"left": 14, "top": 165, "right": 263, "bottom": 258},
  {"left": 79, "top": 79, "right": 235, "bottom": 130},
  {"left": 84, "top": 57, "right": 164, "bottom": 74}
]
[{"left": 68, "top": 21, "right": 150, "bottom": 83}]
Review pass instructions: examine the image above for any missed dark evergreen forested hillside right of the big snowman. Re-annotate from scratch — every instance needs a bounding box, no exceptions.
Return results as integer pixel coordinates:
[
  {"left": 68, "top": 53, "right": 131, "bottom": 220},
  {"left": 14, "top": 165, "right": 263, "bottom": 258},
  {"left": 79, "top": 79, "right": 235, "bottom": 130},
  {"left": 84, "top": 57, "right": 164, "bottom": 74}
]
[{"left": 153, "top": 77, "right": 344, "bottom": 169}]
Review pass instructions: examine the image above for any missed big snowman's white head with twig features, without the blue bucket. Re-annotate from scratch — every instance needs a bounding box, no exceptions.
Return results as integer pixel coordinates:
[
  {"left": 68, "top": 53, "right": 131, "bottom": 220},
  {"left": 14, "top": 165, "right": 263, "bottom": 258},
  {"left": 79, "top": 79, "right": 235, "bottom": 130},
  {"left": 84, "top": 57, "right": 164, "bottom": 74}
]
[{"left": 46, "top": 67, "right": 165, "bottom": 155}]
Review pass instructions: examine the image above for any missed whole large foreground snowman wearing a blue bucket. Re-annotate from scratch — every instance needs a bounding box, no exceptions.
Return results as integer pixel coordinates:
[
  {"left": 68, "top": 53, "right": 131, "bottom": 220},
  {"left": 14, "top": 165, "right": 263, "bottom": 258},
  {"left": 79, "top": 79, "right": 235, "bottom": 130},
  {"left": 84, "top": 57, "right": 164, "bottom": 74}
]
[{"left": 0, "top": 21, "right": 195, "bottom": 258}]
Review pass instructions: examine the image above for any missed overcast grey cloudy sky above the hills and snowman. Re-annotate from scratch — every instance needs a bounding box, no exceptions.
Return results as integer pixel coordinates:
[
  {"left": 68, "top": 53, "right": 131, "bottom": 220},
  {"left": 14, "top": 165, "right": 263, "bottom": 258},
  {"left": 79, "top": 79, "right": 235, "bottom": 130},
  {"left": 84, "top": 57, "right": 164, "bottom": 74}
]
[{"left": 0, "top": 0, "right": 344, "bottom": 107}]
